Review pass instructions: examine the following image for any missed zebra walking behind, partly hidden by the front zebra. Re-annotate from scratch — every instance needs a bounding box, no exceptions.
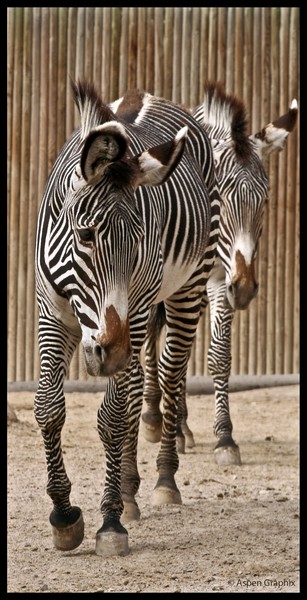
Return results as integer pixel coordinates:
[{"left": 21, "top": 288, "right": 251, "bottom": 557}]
[{"left": 142, "top": 82, "right": 297, "bottom": 464}]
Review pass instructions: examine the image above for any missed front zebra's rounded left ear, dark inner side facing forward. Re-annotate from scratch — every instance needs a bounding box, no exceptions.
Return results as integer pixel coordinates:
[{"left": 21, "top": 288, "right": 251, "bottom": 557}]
[{"left": 80, "top": 121, "right": 128, "bottom": 185}]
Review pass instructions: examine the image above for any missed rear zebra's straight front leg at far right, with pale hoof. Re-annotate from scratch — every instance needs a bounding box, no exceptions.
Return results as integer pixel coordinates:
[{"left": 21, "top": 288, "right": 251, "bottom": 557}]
[{"left": 208, "top": 283, "right": 241, "bottom": 465}]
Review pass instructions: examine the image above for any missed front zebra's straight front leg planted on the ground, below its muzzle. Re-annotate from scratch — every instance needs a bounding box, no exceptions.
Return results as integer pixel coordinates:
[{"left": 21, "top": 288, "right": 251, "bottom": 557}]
[{"left": 95, "top": 371, "right": 129, "bottom": 557}]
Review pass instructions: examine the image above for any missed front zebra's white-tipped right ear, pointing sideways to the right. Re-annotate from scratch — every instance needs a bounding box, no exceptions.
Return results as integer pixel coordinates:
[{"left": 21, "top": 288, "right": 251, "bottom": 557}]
[{"left": 131, "top": 126, "right": 188, "bottom": 187}]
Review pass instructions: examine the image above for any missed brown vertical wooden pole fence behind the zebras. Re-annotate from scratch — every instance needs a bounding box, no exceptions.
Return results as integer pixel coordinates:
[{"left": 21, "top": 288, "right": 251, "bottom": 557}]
[{"left": 7, "top": 7, "right": 300, "bottom": 382}]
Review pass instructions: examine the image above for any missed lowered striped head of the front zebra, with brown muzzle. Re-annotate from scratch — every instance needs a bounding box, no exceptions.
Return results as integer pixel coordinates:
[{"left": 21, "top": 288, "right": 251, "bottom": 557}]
[{"left": 49, "top": 82, "right": 187, "bottom": 376}]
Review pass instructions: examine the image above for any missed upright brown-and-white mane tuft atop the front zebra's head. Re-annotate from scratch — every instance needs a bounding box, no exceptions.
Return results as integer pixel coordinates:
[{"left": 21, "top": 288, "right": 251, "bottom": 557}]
[{"left": 71, "top": 80, "right": 117, "bottom": 140}]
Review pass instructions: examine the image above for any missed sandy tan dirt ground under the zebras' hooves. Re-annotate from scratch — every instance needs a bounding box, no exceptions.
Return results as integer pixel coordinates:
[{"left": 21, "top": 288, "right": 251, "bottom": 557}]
[{"left": 7, "top": 385, "right": 300, "bottom": 593}]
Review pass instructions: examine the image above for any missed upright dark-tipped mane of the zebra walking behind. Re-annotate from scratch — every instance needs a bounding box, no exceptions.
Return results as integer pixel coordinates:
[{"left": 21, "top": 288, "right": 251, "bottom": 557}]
[{"left": 203, "top": 81, "right": 252, "bottom": 159}]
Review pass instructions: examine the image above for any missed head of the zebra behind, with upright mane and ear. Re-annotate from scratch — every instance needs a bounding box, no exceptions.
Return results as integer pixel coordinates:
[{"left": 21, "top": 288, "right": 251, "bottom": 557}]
[{"left": 194, "top": 83, "right": 297, "bottom": 310}]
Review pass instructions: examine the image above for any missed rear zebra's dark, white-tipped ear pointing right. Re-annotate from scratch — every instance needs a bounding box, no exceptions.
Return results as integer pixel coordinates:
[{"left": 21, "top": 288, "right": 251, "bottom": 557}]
[{"left": 249, "top": 100, "right": 298, "bottom": 156}]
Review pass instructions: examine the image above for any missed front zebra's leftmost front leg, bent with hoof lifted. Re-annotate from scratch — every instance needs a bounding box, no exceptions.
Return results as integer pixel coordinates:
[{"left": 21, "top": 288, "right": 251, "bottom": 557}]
[{"left": 34, "top": 317, "right": 84, "bottom": 550}]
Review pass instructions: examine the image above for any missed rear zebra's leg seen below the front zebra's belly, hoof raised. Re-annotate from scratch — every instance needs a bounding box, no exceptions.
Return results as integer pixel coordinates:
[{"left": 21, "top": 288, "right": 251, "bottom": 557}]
[{"left": 142, "top": 332, "right": 162, "bottom": 443}]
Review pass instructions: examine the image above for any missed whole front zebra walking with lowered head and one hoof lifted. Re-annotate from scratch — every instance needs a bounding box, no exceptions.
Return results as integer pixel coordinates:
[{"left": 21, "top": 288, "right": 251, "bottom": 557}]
[{"left": 34, "top": 82, "right": 220, "bottom": 556}]
